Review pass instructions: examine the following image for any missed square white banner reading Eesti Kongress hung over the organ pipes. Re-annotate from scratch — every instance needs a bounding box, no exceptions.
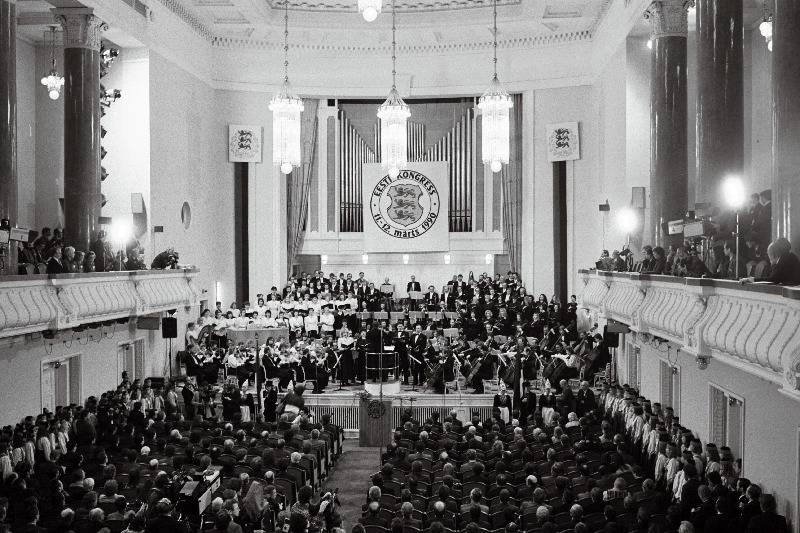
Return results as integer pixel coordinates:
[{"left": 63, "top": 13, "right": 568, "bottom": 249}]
[{"left": 362, "top": 162, "right": 450, "bottom": 253}]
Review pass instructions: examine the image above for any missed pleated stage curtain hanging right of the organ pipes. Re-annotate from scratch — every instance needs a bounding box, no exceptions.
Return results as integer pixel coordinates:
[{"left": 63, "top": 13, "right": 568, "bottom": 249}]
[{"left": 500, "top": 94, "right": 522, "bottom": 272}]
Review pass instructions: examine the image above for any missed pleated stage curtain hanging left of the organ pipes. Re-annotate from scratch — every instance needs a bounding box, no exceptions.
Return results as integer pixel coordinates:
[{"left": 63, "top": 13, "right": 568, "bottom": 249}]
[{"left": 286, "top": 98, "right": 319, "bottom": 274}]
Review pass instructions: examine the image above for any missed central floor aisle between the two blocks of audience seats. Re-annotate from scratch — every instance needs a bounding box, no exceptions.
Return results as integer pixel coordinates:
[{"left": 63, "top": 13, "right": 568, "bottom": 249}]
[{"left": 323, "top": 439, "right": 380, "bottom": 531}]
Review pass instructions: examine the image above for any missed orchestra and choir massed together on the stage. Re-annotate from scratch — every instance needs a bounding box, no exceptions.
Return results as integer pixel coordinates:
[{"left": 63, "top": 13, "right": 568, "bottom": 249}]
[{"left": 181, "top": 272, "right": 608, "bottom": 402}]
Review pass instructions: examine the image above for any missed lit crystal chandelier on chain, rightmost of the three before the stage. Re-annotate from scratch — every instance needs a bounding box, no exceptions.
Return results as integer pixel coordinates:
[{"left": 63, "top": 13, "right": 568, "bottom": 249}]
[{"left": 478, "top": 0, "right": 514, "bottom": 172}]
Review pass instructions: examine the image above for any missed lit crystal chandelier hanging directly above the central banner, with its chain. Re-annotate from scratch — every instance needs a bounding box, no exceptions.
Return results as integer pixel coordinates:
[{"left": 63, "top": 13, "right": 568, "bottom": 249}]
[{"left": 378, "top": 0, "right": 411, "bottom": 178}]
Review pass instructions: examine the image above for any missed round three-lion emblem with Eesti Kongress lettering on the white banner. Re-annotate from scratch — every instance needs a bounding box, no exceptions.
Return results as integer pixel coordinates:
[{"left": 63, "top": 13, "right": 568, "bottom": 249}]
[{"left": 370, "top": 170, "right": 441, "bottom": 239}]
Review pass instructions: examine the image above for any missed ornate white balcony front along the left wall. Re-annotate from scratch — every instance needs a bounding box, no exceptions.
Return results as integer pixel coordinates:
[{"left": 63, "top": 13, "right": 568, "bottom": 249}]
[{"left": 0, "top": 269, "right": 199, "bottom": 338}]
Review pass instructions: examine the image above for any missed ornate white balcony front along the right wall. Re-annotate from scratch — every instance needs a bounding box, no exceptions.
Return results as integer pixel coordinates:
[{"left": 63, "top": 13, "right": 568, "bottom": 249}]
[{"left": 579, "top": 270, "right": 800, "bottom": 398}]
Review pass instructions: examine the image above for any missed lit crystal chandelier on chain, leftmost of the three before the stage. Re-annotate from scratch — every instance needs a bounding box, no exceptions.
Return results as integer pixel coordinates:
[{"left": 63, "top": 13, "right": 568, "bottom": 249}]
[{"left": 269, "top": 0, "right": 303, "bottom": 174}]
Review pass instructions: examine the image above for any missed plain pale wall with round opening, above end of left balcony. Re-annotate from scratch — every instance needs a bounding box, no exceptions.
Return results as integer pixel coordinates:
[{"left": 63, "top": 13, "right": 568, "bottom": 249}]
[{"left": 150, "top": 52, "right": 235, "bottom": 307}]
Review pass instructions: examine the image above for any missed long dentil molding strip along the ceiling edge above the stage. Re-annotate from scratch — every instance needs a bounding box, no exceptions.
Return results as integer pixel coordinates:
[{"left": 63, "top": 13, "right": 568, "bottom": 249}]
[{"left": 211, "top": 30, "right": 592, "bottom": 54}]
